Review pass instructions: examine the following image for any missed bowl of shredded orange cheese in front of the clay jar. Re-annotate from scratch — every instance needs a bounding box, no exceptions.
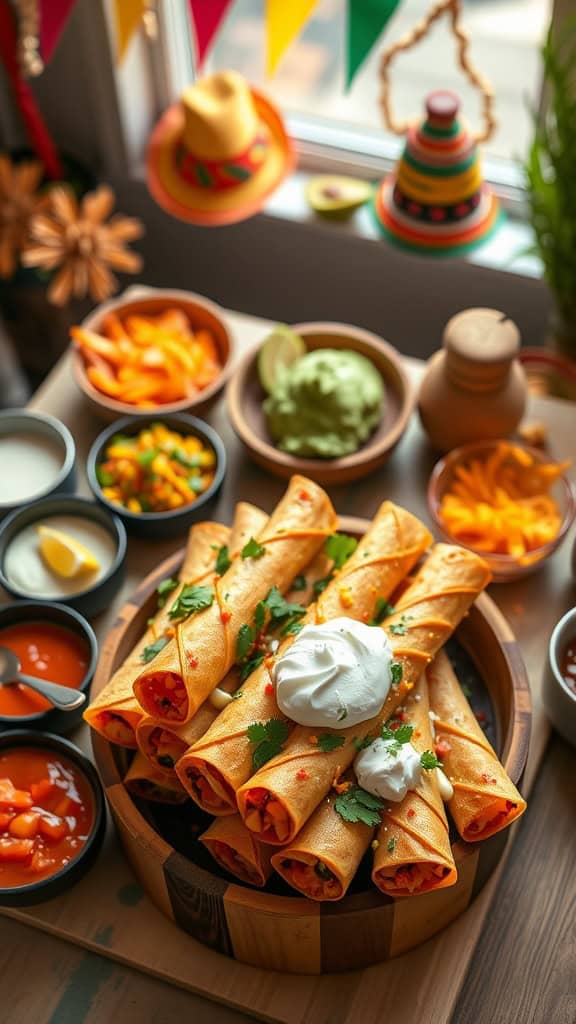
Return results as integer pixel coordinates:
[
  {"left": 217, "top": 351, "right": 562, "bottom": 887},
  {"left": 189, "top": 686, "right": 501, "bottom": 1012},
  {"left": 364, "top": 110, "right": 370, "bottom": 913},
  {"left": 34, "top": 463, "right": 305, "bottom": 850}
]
[{"left": 428, "top": 440, "right": 576, "bottom": 583}]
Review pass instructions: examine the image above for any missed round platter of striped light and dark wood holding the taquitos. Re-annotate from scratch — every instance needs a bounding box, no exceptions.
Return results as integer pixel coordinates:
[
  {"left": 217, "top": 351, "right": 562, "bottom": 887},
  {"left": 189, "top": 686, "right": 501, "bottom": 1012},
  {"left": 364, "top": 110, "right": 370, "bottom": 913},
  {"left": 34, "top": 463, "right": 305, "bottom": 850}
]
[{"left": 92, "top": 518, "right": 531, "bottom": 974}]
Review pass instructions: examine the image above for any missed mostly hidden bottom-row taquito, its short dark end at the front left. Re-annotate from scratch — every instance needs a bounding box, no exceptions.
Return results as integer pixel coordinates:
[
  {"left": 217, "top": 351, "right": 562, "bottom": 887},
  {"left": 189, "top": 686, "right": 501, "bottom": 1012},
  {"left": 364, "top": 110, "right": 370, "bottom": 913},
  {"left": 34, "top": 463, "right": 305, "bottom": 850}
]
[{"left": 200, "top": 814, "right": 272, "bottom": 889}]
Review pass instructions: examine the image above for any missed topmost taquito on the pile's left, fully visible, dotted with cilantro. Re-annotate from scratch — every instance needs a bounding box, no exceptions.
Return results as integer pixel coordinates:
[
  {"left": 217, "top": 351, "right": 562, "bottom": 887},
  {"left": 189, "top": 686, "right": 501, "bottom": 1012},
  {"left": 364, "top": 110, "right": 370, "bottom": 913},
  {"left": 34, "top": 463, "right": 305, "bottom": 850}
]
[{"left": 134, "top": 476, "right": 336, "bottom": 725}]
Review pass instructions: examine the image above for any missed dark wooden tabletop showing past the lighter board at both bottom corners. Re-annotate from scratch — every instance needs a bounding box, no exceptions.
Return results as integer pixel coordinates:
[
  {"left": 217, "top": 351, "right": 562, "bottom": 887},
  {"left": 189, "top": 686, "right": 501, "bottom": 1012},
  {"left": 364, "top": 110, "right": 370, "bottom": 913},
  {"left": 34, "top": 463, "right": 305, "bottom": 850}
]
[{"left": 0, "top": 737, "right": 576, "bottom": 1024}]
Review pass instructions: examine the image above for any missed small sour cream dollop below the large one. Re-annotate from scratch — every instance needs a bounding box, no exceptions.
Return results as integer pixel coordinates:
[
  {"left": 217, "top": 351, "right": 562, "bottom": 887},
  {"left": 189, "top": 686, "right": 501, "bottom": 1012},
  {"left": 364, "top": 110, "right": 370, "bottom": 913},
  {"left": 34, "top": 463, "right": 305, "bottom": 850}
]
[{"left": 354, "top": 738, "right": 422, "bottom": 802}]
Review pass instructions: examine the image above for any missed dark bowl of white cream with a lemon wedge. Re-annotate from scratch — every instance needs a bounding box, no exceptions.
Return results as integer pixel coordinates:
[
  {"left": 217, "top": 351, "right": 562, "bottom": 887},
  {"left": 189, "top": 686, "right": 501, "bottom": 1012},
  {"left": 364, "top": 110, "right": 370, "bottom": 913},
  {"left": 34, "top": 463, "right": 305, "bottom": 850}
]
[{"left": 0, "top": 496, "right": 127, "bottom": 616}]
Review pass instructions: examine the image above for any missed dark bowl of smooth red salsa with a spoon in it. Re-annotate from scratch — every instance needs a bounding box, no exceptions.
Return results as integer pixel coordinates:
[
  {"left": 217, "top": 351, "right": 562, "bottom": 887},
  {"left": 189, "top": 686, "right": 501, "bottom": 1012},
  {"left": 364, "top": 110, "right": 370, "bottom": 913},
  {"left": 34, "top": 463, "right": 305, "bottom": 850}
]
[{"left": 0, "top": 601, "right": 98, "bottom": 732}]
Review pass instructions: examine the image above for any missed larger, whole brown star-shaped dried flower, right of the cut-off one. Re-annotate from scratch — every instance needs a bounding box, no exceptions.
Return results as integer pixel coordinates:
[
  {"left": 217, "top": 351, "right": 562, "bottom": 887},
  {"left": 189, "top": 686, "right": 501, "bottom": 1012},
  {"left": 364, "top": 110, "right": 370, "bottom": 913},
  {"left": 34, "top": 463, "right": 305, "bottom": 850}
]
[{"left": 22, "top": 185, "right": 143, "bottom": 306}]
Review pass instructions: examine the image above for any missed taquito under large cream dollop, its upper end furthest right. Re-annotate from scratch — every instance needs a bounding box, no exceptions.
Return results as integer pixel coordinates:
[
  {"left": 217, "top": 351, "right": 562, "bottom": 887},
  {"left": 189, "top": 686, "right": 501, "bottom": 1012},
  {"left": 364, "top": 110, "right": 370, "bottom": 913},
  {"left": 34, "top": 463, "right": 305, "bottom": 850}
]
[{"left": 237, "top": 544, "right": 490, "bottom": 846}]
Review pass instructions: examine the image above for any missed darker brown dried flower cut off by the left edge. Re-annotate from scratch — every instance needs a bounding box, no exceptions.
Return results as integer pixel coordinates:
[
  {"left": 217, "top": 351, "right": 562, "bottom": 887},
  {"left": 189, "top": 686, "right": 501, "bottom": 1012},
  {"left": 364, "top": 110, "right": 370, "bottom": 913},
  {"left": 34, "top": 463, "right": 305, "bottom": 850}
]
[{"left": 0, "top": 154, "right": 45, "bottom": 278}]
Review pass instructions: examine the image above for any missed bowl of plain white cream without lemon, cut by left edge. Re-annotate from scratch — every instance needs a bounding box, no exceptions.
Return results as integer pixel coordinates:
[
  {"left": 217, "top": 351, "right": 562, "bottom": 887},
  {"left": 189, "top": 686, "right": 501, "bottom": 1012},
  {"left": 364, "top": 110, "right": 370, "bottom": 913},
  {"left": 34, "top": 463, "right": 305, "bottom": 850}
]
[{"left": 0, "top": 409, "right": 76, "bottom": 518}]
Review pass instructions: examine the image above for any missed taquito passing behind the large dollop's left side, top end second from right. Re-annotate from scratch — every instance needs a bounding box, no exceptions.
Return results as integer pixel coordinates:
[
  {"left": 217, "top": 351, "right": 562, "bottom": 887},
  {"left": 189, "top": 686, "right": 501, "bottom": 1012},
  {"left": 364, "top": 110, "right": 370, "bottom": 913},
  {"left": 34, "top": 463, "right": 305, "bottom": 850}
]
[{"left": 176, "top": 502, "right": 431, "bottom": 814}]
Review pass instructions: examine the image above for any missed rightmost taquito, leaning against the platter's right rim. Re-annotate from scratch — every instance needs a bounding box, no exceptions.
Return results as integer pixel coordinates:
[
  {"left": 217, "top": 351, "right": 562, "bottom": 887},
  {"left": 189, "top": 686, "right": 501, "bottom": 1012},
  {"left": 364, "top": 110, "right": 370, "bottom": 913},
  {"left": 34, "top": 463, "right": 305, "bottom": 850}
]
[{"left": 426, "top": 651, "right": 526, "bottom": 843}]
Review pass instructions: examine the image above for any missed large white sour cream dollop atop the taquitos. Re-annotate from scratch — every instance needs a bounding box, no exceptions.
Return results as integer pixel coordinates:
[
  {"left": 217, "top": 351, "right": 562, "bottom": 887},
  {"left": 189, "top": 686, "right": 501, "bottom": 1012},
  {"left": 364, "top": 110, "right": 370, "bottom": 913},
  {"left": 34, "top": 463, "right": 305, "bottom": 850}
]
[{"left": 273, "top": 615, "right": 393, "bottom": 729}]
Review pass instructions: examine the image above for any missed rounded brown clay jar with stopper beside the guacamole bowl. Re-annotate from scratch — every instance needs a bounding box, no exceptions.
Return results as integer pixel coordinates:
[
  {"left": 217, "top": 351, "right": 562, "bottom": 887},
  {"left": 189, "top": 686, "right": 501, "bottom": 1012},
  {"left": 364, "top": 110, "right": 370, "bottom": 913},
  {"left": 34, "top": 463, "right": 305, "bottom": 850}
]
[{"left": 418, "top": 308, "right": 527, "bottom": 452}]
